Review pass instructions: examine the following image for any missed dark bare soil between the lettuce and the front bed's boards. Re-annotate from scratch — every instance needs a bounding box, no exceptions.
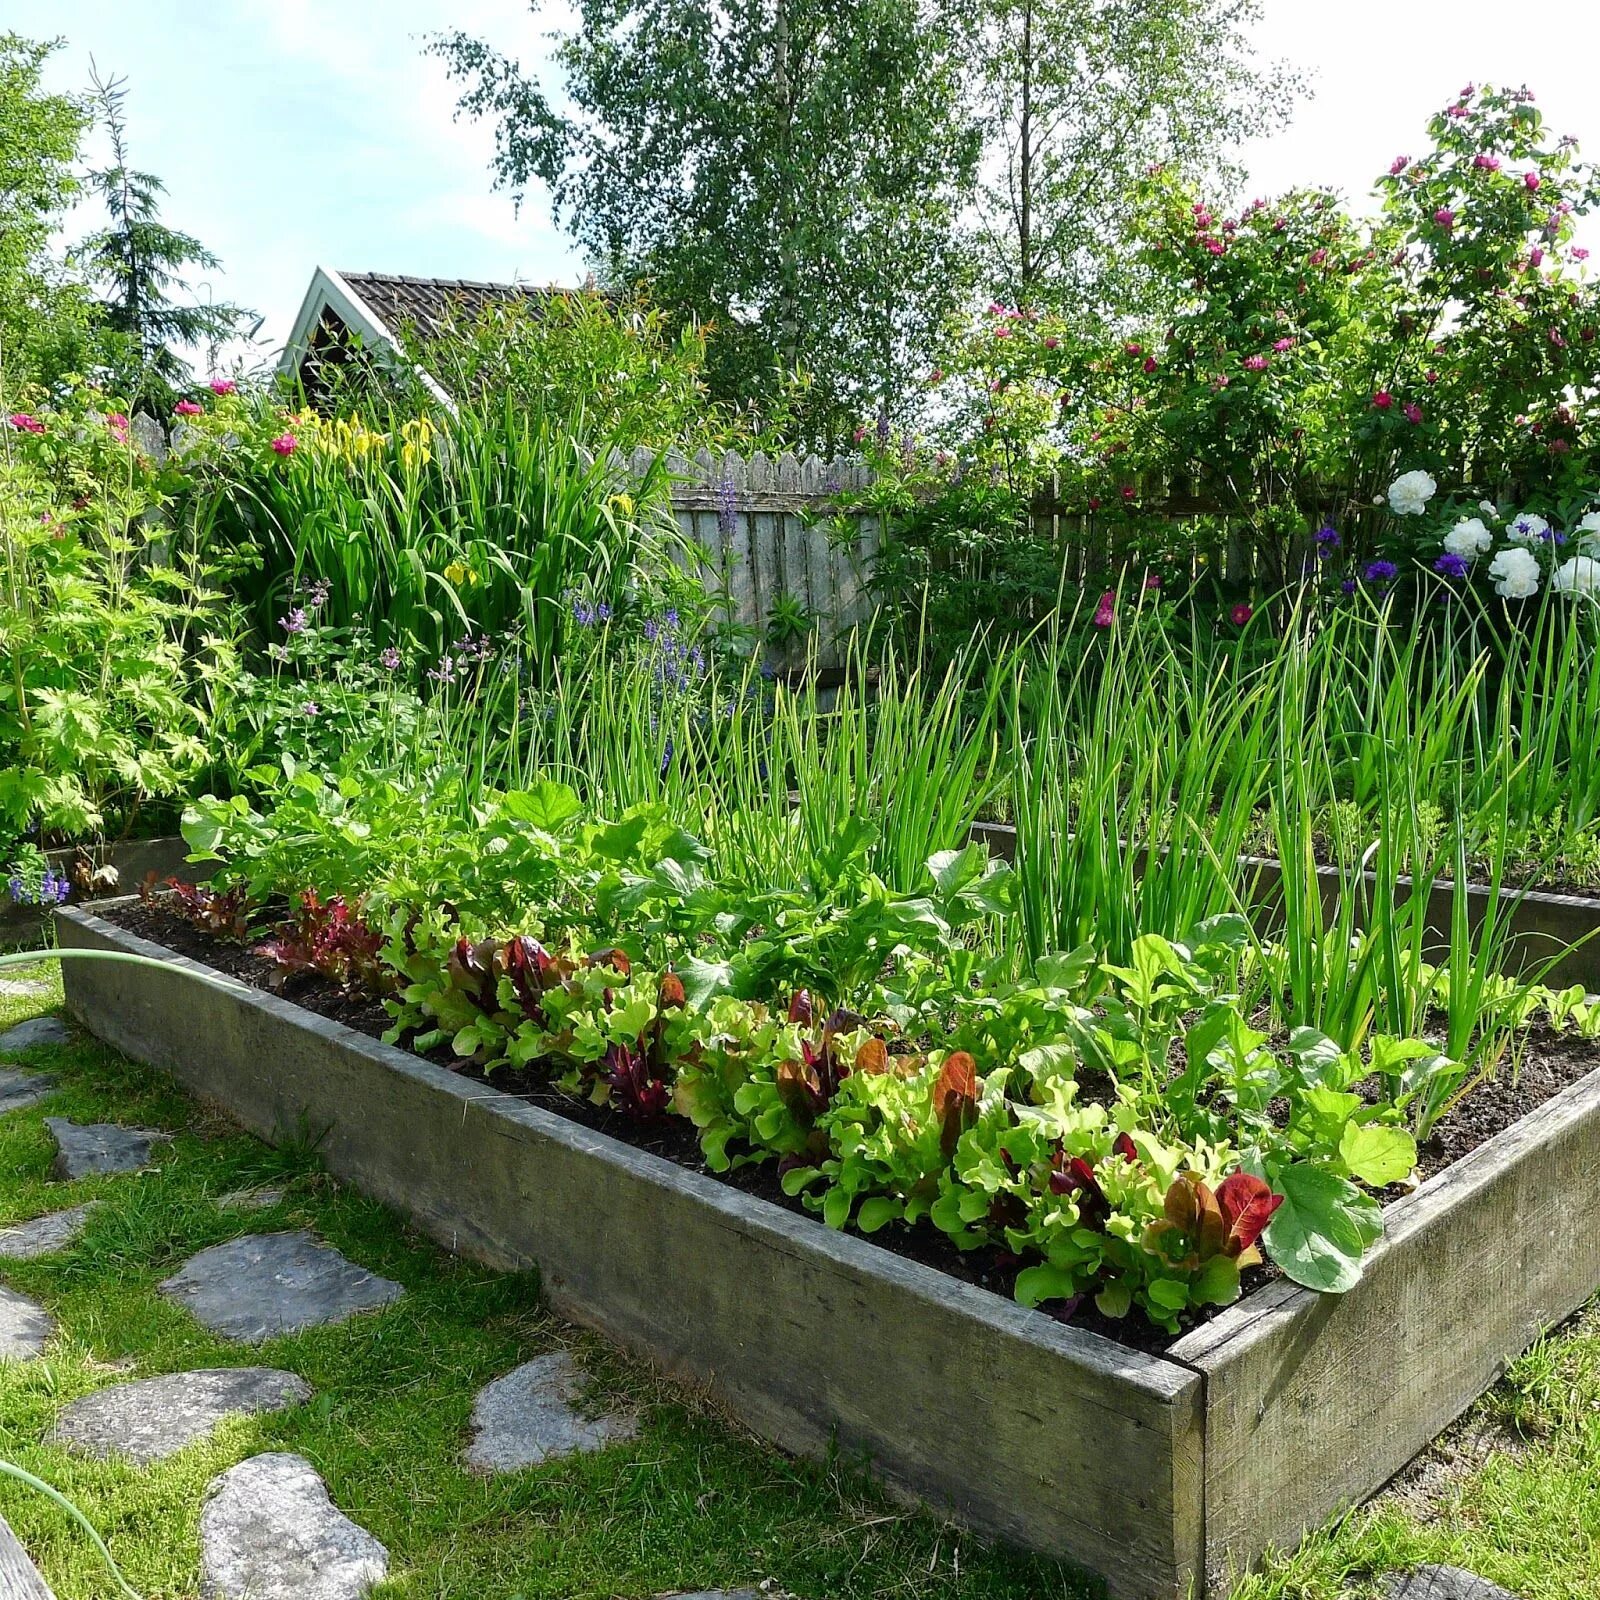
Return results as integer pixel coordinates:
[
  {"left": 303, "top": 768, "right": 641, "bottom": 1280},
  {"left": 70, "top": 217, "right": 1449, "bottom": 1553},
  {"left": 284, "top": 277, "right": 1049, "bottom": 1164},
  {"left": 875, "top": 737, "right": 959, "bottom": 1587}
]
[{"left": 101, "top": 901, "right": 1600, "bottom": 1354}]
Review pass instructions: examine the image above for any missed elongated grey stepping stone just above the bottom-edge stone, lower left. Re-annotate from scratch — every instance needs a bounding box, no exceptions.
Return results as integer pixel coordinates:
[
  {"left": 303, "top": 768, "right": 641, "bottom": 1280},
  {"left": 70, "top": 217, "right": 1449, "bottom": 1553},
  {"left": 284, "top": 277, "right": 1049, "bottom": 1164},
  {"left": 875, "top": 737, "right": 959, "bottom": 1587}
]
[{"left": 48, "top": 1366, "right": 310, "bottom": 1467}]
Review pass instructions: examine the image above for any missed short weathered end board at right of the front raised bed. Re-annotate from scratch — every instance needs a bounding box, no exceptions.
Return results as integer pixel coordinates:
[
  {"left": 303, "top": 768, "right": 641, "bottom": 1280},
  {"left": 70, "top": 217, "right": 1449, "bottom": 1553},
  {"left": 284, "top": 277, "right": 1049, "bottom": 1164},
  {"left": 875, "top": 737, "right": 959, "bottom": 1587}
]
[{"left": 1170, "top": 1072, "right": 1600, "bottom": 1595}]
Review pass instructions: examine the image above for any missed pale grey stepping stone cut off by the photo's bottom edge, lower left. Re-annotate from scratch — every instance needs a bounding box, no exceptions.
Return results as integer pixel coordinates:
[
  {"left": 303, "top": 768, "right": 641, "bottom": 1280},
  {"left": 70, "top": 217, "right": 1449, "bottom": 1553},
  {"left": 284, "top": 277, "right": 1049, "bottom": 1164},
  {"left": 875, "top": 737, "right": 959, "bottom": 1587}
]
[{"left": 200, "top": 1454, "right": 389, "bottom": 1600}]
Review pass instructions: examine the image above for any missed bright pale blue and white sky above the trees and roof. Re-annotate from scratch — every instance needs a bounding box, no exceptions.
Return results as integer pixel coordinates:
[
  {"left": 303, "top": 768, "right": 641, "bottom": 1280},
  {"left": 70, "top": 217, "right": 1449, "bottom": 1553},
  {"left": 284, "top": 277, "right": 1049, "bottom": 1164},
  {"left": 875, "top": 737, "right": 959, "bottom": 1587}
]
[{"left": 21, "top": 0, "right": 1600, "bottom": 376}]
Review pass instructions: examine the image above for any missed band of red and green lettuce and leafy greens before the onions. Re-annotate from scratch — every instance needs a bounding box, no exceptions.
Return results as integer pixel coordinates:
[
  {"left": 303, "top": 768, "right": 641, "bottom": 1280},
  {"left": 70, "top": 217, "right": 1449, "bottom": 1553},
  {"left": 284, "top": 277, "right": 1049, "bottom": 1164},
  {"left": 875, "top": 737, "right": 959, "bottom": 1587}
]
[{"left": 163, "top": 755, "right": 1600, "bottom": 1333}]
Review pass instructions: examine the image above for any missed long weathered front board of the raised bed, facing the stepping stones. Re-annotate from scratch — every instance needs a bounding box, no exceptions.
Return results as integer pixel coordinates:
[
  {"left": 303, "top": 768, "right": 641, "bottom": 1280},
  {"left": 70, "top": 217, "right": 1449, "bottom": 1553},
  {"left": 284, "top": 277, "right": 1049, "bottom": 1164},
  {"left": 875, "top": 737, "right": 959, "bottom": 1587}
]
[{"left": 58, "top": 909, "right": 1202, "bottom": 1600}]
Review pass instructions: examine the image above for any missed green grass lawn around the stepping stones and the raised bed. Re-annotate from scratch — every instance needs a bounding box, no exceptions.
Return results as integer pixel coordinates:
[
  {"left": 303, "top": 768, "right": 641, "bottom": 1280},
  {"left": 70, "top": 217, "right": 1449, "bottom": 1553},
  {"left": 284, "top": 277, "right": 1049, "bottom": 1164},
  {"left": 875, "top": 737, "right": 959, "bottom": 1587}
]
[{"left": 0, "top": 966, "right": 1600, "bottom": 1600}]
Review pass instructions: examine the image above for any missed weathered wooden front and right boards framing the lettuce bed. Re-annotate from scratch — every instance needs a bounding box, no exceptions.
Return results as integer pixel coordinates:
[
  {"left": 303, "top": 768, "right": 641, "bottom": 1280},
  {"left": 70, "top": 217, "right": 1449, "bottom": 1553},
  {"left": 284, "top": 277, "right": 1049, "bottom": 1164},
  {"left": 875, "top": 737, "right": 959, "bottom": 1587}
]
[{"left": 58, "top": 907, "right": 1600, "bottom": 1600}]
